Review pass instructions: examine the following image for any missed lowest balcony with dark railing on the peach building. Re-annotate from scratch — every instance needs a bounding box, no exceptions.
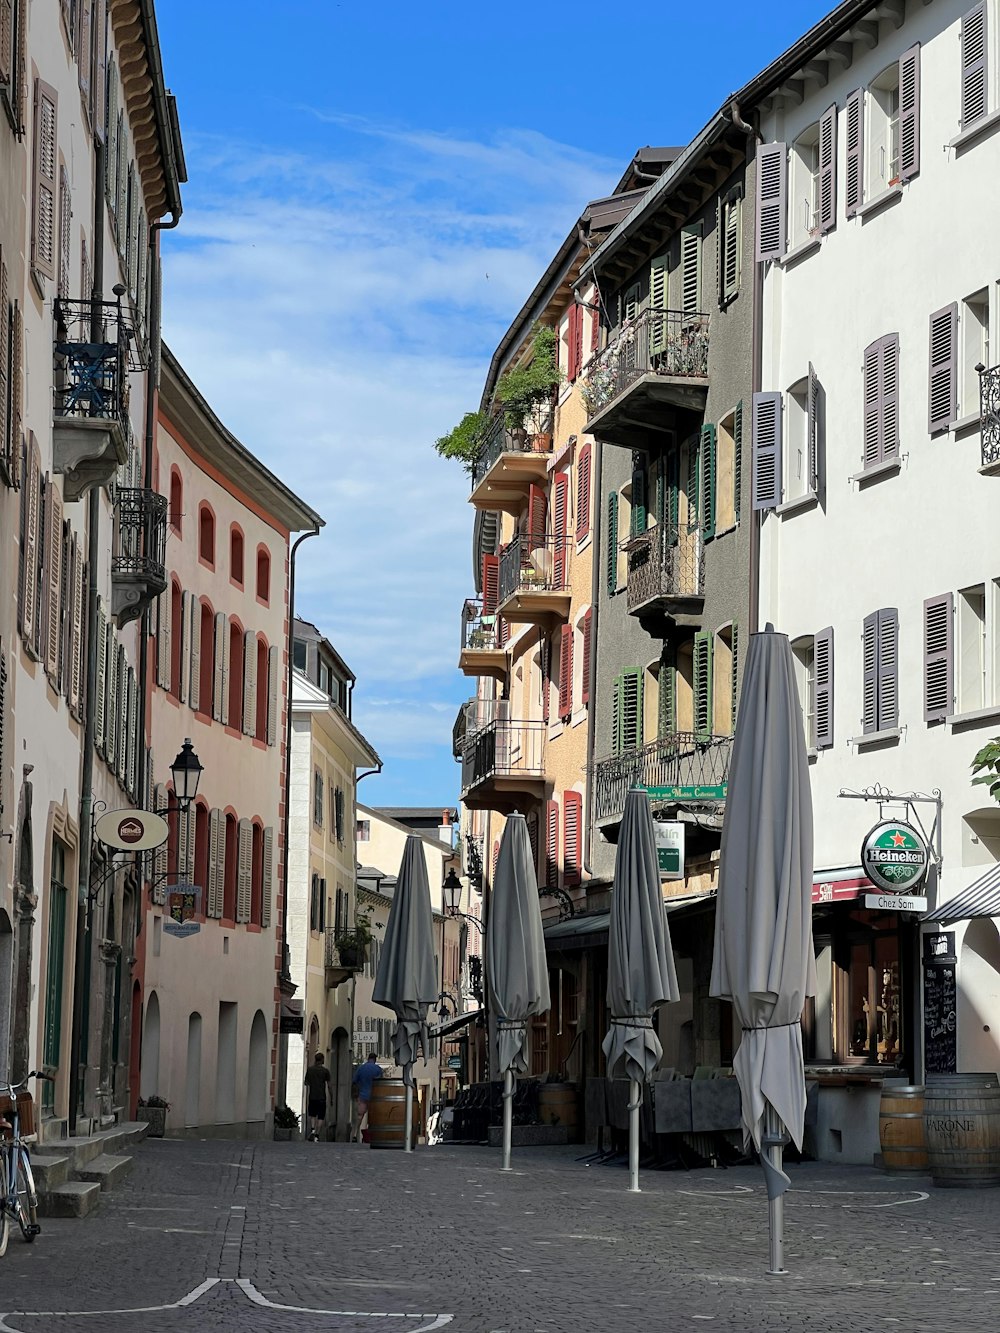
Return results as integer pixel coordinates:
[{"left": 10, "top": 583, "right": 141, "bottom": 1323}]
[{"left": 461, "top": 718, "right": 547, "bottom": 814}]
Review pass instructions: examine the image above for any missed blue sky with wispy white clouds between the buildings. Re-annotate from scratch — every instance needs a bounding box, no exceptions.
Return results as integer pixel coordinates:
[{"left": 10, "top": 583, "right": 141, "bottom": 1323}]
[{"left": 159, "top": 0, "right": 828, "bottom": 805}]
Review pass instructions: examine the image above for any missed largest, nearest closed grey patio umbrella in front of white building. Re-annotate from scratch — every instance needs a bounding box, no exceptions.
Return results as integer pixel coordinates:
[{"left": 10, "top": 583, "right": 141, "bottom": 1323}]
[{"left": 711, "top": 625, "right": 816, "bottom": 1273}]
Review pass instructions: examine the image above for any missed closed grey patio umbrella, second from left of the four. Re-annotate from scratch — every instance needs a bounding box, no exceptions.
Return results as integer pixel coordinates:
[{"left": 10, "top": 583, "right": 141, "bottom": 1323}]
[{"left": 487, "top": 814, "right": 549, "bottom": 1170}]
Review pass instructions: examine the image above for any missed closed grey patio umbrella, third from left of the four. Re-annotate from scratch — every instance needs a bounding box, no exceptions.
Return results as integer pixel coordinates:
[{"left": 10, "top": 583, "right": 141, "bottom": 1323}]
[{"left": 604, "top": 789, "right": 680, "bottom": 1192}]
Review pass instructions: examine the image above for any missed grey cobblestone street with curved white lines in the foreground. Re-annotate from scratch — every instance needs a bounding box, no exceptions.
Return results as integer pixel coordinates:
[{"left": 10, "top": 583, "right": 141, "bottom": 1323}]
[{"left": 0, "top": 1140, "right": 1000, "bottom": 1333}]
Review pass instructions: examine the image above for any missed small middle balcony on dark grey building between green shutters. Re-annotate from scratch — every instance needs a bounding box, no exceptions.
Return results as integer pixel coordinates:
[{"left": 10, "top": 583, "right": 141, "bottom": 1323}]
[{"left": 621, "top": 527, "right": 705, "bottom": 639}]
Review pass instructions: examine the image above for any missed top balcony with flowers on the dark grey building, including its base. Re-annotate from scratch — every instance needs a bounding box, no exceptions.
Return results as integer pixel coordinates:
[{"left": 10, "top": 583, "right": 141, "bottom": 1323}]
[{"left": 583, "top": 311, "right": 709, "bottom": 449}]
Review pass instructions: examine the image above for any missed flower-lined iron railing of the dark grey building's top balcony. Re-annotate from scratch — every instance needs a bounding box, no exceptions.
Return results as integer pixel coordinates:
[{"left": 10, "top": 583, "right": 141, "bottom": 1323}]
[{"left": 583, "top": 311, "right": 708, "bottom": 417}]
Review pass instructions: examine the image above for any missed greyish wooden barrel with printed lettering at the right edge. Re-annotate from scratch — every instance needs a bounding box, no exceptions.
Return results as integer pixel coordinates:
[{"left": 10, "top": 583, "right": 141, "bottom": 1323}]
[{"left": 924, "top": 1074, "right": 1000, "bottom": 1189}]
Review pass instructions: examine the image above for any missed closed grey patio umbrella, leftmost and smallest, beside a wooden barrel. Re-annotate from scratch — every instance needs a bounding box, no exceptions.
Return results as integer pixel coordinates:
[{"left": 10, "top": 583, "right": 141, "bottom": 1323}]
[{"left": 372, "top": 833, "right": 437, "bottom": 1152}]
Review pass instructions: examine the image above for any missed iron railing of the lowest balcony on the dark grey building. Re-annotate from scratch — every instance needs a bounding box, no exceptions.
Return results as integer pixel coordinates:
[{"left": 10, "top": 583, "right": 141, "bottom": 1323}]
[{"left": 593, "top": 732, "right": 732, "bottom": 820}]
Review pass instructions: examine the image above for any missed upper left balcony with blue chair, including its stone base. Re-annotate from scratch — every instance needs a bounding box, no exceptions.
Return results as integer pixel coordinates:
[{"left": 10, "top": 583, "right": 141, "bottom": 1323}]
[{"left": 52, "top": 300, "right": 143, "bottom": 500}]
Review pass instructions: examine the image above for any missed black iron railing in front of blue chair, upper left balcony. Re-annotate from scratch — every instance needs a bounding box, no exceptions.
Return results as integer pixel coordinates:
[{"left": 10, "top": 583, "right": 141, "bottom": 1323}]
[{"left": 53, "top": 297, "right": 143, "bottom": 425}]
